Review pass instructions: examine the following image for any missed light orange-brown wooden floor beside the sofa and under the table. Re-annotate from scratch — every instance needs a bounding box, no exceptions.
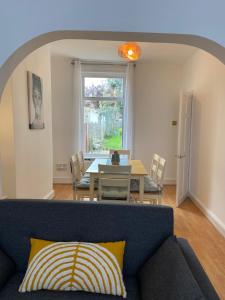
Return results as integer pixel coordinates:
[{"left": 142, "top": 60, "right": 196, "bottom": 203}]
[{"left": 54, "top": 184, "right": 225, "bottom": 300}]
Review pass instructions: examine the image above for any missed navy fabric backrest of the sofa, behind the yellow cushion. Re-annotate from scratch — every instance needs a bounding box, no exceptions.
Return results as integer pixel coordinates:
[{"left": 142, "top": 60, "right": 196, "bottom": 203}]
[{"left": 0, "top": 200, "right": 173, "bottom": 275}]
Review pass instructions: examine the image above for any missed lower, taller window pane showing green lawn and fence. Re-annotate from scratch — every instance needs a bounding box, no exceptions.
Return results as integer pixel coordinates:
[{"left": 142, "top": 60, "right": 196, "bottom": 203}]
[{"left": 84, "top": 100, "right": 123, "bottom": 153}]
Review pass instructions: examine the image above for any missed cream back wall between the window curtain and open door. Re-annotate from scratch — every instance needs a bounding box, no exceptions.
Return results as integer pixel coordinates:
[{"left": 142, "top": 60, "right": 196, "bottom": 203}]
[{"left": 134, "top": 62, "right": 181, "bottom": 183}]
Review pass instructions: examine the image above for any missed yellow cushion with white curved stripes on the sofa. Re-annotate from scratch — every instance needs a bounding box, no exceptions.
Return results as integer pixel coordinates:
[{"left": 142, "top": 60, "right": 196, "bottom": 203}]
[{"left": 19, "top": 239, "right": 126, "bottom": 298}]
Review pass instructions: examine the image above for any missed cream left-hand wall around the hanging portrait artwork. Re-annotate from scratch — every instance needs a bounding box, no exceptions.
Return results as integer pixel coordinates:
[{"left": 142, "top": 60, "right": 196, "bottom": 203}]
[{"left": 0, "top": 47, "right": 52, "bottom": 198}]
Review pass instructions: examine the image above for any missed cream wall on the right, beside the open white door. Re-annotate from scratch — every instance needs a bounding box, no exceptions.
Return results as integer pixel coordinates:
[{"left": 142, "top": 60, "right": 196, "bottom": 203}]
[{"left": 183, "top": 50, "right": 225, "bottom": 235}]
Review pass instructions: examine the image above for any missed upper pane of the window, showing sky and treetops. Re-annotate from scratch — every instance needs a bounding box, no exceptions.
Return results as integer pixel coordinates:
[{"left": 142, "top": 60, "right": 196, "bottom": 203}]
[{"left": 84, "top": 77, "right": 123, "bottom": 98}]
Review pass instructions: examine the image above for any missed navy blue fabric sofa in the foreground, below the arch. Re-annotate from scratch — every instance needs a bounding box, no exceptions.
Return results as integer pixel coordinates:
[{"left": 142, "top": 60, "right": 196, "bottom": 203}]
[{"left": 0, "top": 200, "right": 218, "bottom": 300}]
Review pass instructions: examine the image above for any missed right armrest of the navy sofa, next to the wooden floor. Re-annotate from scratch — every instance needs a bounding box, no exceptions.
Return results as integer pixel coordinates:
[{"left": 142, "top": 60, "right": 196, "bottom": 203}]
[{"left": 177, "top": 238, "right": 219, "bottom": 300}]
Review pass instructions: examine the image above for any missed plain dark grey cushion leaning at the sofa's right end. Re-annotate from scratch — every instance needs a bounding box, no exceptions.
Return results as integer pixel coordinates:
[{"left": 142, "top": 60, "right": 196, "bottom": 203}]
[{"left": 138, "top": 236, "right": 205, "bottom": 300}]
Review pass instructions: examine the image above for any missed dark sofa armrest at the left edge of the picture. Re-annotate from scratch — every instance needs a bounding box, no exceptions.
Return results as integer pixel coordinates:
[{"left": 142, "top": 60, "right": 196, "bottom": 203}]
[{"left": 0, "top": 249, "right": 16, "bottom": 290}]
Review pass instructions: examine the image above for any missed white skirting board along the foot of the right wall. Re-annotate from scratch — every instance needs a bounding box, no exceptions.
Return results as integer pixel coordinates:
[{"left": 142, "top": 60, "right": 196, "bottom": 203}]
[{"left": 188, "top": 193, "right": 225, "bottom": 238}]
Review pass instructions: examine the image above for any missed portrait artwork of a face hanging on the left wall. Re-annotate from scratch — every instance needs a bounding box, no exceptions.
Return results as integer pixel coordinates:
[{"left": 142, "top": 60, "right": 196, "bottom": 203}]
[{"left": 27, "top": 71, "right": 45, "bottom": 129}]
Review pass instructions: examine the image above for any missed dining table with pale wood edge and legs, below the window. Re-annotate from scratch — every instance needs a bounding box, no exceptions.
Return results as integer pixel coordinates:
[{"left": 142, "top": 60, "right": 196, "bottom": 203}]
[{"left": 86, "top": 158, "right": 148, "bottom": 201}]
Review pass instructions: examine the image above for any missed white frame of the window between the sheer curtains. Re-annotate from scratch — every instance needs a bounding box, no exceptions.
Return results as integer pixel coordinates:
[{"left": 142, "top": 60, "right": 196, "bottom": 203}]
[{"left": 81, "top": 71, "right": 126, "bottom": 158}]
